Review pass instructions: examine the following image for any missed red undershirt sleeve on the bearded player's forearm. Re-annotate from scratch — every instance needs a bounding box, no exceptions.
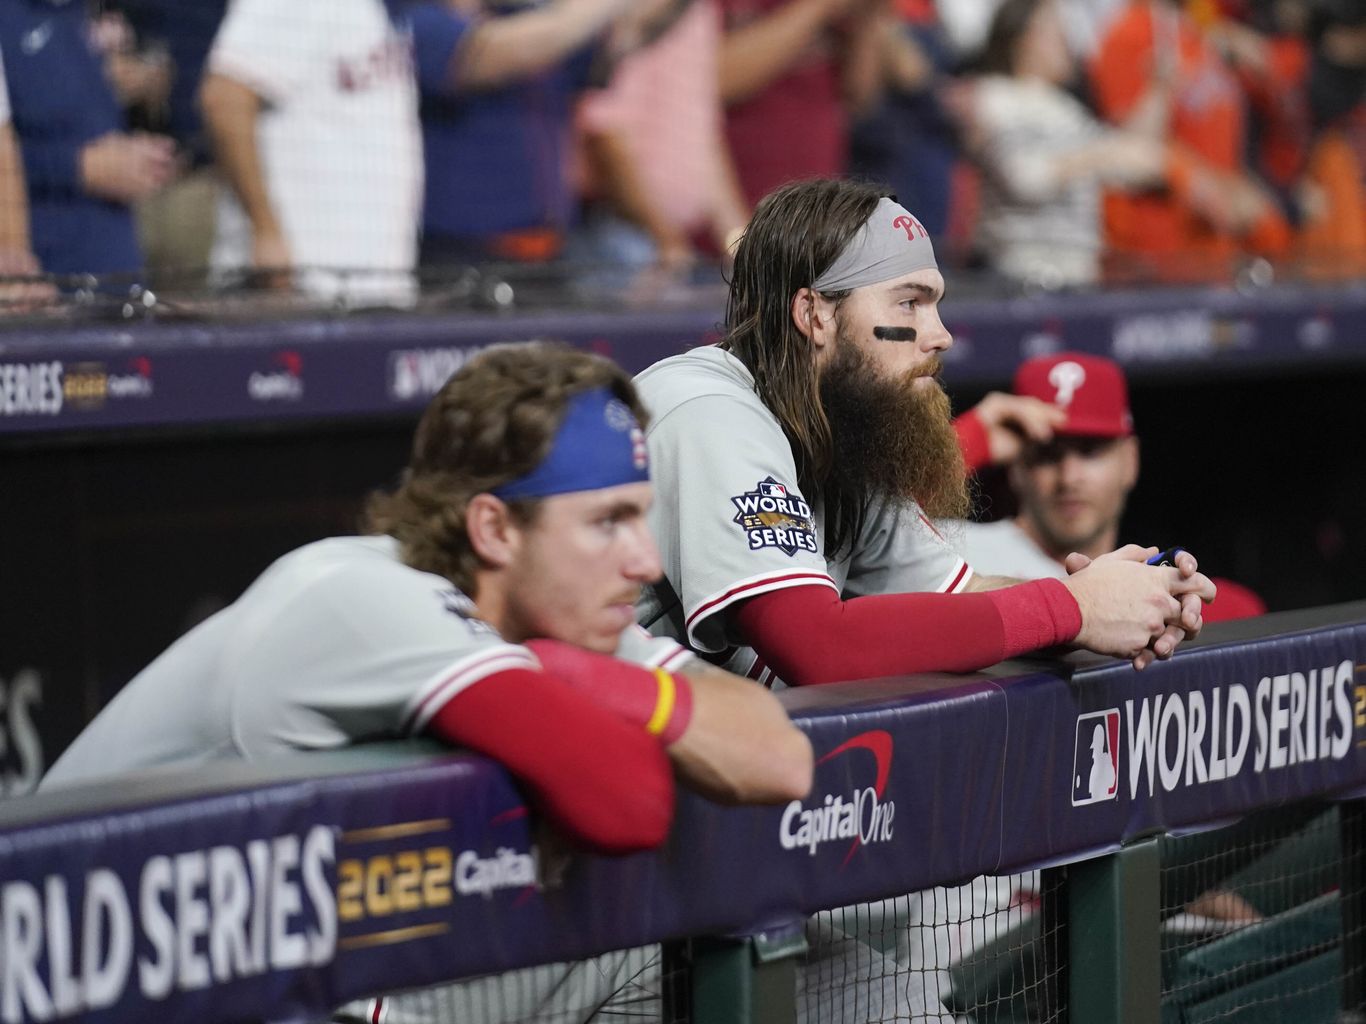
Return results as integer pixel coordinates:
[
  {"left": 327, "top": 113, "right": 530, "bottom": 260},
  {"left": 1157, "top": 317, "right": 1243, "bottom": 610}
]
[{"left": 729, "top": 579, "right": 1082, "bottom": 685}]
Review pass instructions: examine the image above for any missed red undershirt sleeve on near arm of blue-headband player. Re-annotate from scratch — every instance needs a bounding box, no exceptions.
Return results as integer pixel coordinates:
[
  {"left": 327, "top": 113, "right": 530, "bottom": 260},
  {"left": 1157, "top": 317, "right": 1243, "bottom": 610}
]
[{"left": 426, "top": 669, "right": 673, "bottom": 853}]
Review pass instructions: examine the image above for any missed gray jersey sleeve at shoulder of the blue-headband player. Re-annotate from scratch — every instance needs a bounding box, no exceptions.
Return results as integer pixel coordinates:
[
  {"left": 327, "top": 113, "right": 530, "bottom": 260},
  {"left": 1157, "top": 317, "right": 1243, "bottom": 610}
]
[{"left": 225, "top": 548, "right": 540, "bottom": 756}]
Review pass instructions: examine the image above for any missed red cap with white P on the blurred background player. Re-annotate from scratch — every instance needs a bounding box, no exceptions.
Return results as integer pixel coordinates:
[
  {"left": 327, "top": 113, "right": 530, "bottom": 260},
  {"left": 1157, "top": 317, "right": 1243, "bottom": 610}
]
[{"left": 1014, "top": 352, "right": 1134, "bottom": 437}]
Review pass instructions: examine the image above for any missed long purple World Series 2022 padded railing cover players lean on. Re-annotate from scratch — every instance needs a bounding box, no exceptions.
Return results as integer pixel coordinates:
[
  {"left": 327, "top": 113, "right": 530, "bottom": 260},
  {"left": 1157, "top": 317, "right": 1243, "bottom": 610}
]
[{"left": 0, "top": 606, "right": 1366, "bottom": 1024}]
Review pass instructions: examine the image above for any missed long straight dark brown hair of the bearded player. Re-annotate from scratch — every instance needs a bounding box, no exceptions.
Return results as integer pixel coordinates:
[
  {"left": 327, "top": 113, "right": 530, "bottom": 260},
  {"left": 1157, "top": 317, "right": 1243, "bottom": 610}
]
[{"left": 721, "top": 179, "right": 889, "bottom": 557}]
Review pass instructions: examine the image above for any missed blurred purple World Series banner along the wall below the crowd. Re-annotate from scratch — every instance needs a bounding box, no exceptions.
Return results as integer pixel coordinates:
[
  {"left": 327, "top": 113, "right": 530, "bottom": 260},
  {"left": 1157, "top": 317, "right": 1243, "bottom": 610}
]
[{"left": 0, "top": 287, "right": 1366, "bottom": 436}]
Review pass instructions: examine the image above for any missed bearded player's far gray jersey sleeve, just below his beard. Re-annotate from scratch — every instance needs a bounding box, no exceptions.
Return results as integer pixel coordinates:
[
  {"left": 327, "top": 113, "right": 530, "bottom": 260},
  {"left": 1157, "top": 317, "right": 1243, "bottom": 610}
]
[{"left": 844, "top": 502, "right": 973, "bottom": 597}]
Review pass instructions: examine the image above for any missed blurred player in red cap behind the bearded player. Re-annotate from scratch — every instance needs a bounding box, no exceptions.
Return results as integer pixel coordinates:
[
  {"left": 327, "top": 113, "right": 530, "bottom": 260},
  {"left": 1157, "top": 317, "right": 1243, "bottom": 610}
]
[{"left": 948, "top": 352, "right": 1266, "bottom": 623}]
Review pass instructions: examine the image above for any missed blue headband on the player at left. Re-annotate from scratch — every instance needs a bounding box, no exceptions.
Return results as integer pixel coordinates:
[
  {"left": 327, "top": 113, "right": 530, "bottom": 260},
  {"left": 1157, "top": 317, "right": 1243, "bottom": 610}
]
[{"left": 489, "top": 388, "right": 650, "bottom": 501}]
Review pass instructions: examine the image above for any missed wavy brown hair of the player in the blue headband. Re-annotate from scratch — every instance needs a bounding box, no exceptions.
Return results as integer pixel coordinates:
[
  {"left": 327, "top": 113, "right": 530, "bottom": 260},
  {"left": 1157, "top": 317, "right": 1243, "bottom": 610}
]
[{"left": 363, "top": 341, "right": 646, "bottom": 598}]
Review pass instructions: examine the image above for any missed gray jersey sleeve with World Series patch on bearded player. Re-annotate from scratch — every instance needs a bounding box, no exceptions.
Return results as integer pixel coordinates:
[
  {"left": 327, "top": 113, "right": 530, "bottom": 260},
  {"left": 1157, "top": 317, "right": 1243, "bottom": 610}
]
[{"left": 649, "top": 395, "right": 835, "bottom": 653}]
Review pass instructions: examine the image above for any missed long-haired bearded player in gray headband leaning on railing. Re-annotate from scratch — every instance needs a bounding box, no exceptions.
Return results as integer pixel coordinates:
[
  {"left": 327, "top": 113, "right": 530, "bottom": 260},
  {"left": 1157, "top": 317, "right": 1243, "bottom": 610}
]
[{"left": 637, "top": 180, "right": 1214, "bottom": 685}]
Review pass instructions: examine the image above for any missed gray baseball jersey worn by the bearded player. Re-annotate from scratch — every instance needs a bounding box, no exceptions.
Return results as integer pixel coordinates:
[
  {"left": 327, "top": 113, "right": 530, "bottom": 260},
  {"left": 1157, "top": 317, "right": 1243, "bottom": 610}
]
[{"left": 635, "top": 348, "right": 973, "bottom": 683}]
